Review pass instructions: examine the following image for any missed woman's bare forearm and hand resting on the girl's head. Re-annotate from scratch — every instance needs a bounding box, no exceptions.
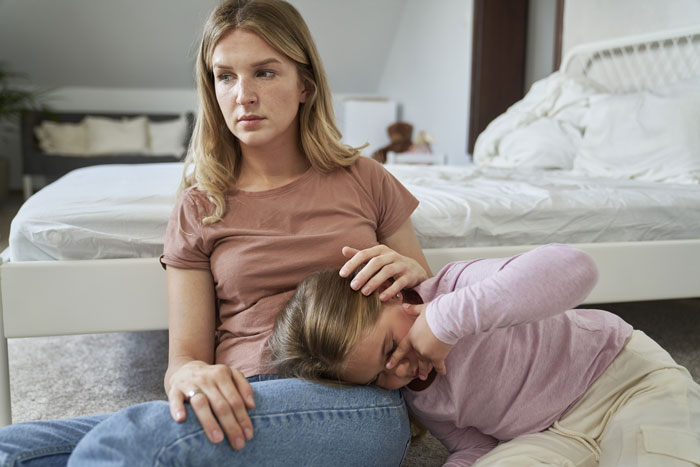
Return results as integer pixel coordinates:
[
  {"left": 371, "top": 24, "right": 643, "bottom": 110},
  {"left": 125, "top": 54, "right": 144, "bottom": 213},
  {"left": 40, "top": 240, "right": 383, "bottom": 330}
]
[{"left": 340, "top": 218, "right": 432, "bottom": 301}]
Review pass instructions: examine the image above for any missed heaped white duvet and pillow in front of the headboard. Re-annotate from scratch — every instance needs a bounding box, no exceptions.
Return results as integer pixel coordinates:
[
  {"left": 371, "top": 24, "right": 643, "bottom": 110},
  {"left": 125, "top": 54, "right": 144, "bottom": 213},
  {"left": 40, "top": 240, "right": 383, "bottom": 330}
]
[{"left": 474, "top": 72, "right": 700, "bottom": 184}]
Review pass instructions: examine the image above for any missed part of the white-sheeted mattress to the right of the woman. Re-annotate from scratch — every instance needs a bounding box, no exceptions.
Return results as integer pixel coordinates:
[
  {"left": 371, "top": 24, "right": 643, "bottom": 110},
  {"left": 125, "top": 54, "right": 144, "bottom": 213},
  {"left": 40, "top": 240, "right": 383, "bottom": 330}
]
[{"left": 387, "top": 165, "right": 700, "bottom": 248}]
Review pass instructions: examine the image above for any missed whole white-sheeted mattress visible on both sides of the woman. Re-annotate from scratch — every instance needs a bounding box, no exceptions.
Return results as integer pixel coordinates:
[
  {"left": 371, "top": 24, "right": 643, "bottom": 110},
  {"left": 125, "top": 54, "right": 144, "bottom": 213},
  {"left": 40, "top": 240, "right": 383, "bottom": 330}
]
[{"left": 10, "top": 163, "right": 700, "bottom": 261}]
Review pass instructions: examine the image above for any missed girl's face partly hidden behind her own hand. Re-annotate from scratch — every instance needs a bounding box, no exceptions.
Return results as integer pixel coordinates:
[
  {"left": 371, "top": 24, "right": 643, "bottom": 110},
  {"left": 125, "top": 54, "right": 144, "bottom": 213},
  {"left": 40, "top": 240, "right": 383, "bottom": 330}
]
[{"left": 343, "top": 295, "right": 418, "bottom": 389}]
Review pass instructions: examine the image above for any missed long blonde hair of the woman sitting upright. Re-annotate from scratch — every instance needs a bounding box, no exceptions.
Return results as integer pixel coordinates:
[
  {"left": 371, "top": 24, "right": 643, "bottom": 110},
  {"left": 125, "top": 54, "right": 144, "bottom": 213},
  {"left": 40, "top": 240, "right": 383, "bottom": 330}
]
[{"left": 181, "top": 0, "right": 359, "bottom": 224}]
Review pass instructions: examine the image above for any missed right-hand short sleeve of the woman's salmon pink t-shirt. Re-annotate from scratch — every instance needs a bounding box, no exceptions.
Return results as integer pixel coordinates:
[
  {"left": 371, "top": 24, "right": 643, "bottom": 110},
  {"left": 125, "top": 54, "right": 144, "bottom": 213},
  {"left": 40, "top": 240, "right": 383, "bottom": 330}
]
[{"left": 357, "top": 157, "right": 418, "bottom": 241}]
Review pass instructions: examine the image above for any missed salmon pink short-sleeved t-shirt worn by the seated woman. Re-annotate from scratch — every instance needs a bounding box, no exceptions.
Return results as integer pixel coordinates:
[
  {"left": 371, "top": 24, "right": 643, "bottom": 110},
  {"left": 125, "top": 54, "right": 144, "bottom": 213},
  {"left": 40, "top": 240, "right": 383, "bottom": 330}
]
[{"left": 161, "top": 157, "right": 418, "bottom": 376}]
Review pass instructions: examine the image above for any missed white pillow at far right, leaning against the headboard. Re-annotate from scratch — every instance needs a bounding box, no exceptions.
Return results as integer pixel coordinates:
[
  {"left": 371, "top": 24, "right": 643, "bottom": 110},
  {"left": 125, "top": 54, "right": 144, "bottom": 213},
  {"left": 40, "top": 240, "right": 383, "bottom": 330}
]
[{"left": 574, "top": 78, "right": 700, "bottom": 183}]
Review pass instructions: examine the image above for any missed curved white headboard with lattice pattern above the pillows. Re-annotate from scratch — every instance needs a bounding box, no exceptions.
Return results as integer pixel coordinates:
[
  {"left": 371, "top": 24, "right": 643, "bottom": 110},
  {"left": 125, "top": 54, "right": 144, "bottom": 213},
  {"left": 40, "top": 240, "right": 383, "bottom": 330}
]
[{"left": 559, "top": 26, "right": 700, "bottom": 93}]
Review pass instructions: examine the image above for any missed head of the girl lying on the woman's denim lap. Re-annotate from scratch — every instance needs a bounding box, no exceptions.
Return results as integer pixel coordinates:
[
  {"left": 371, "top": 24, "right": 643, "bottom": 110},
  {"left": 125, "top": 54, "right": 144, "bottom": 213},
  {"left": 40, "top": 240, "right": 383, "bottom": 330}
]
[{"left": 268, "top": 271, "right": 418, "bottom": 389}]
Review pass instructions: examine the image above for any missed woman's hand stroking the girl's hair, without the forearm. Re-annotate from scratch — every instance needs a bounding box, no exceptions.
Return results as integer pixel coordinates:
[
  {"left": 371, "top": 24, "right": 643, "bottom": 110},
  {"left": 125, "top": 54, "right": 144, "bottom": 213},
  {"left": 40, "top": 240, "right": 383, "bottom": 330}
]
[{"left": 340, "top": 245, "right": 428, "bottom": 301}]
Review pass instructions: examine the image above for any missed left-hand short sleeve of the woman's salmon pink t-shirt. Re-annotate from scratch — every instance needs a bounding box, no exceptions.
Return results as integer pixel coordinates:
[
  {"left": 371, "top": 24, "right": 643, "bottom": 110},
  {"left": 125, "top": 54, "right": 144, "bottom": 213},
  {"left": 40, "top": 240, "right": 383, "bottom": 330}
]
[{"left": 160, "top": 189, "right": 210, "bottom": 269}]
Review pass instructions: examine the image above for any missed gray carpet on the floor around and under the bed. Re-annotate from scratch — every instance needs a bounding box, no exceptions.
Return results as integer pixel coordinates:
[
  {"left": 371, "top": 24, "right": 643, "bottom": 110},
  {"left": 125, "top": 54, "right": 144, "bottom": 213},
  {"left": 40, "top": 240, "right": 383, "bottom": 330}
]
[{"left": 9, "top": 300, "right": 700, "bottom": 467}]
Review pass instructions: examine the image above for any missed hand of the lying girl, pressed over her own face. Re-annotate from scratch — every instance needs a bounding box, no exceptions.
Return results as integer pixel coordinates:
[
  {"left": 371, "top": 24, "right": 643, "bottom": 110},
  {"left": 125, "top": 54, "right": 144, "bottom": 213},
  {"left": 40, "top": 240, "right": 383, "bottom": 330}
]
[{"left": 386, "top": 303, "right": 453, "bottom": 379}]
